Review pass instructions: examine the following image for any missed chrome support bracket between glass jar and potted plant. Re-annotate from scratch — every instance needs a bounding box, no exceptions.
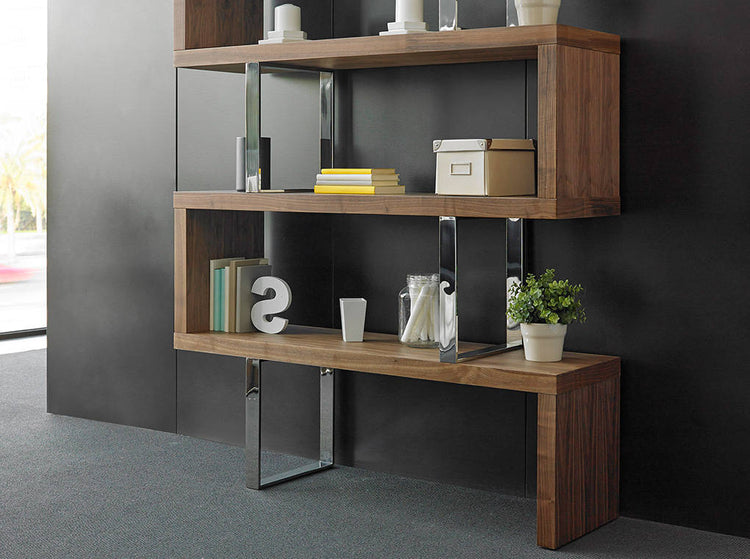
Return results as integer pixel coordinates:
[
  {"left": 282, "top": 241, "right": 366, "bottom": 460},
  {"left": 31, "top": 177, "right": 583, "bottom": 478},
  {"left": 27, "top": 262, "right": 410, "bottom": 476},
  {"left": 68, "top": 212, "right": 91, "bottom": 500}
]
[{"left": 438, "top": 216, "right": 526, "bottom": 363}]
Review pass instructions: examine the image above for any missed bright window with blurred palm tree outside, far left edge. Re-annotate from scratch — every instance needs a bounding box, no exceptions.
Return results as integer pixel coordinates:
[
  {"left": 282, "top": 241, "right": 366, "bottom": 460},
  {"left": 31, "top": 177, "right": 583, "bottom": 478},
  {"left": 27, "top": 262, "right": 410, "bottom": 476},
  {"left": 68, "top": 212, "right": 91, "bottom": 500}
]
[{"left": 0, "top": 0, "right": 47, "bottom": 334}]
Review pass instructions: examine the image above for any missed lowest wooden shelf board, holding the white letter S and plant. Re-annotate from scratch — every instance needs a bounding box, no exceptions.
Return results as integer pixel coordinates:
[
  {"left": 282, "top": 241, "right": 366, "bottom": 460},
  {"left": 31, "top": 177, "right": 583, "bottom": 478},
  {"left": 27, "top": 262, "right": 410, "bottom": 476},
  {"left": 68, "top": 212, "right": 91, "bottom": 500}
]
[{"left": 174, "top": 326, "right": 620, "bottom": 394}]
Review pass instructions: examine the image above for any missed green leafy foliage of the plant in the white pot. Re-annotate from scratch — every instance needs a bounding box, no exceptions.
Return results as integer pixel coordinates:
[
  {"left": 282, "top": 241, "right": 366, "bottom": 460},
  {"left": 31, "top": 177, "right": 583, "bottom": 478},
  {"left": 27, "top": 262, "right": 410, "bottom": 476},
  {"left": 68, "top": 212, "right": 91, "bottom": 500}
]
[{"left": 507, "top": 268, "right": 586, "bottom": 324}]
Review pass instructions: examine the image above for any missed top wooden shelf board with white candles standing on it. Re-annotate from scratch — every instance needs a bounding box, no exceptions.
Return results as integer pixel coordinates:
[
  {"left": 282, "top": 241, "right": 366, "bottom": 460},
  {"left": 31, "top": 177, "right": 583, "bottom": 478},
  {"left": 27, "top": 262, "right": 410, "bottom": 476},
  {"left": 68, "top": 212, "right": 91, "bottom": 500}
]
[{"left": 174, "top": 25, "right": 620, "bottom": 73}]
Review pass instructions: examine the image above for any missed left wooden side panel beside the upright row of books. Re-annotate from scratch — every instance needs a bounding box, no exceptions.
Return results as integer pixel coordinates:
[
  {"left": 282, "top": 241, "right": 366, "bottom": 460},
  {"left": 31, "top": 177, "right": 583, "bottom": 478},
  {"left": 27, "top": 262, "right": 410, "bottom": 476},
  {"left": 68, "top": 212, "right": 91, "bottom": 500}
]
[{"left": 175, "top": 209, "right": 263, "bottom": 333}]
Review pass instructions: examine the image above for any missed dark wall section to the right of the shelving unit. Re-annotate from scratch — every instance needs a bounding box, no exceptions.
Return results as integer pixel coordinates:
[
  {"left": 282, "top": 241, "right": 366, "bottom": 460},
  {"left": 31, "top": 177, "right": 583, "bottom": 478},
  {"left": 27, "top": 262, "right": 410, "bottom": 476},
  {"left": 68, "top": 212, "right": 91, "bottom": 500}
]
[{"left": 552, "top": 0, "right": 750, "bottom": 536}]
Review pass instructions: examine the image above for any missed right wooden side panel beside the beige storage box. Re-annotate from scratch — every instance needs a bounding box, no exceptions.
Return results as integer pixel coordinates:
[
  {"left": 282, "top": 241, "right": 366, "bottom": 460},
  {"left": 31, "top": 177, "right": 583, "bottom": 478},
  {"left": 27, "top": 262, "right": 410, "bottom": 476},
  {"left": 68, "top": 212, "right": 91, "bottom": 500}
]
[{"left": 538, "top": 45, "right": 620, "bottom": 200}]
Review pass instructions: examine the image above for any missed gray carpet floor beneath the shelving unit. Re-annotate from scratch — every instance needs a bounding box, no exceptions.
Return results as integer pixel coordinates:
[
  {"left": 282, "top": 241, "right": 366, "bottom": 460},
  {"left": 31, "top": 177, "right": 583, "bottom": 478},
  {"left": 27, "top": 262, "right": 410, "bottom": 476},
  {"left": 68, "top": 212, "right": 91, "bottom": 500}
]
[{"left": 0, "top": 350, "right": 750, "bottom": 559}]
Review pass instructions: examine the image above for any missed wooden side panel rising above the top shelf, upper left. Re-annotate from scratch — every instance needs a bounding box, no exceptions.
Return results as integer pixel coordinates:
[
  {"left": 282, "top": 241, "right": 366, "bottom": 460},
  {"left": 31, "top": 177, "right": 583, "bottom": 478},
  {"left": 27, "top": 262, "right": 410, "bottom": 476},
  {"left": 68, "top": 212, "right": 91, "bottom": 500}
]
[{"left": 182, "top": 0, "right": 263, "bottom": 50}]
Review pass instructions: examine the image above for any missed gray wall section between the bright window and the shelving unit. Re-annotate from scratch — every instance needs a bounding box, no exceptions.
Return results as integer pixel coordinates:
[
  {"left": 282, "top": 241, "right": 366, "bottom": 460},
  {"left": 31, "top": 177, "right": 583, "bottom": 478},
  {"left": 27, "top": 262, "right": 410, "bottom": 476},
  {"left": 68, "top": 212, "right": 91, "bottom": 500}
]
[{"left": 47, "top": 0, "right": 175, "bottom": 431}]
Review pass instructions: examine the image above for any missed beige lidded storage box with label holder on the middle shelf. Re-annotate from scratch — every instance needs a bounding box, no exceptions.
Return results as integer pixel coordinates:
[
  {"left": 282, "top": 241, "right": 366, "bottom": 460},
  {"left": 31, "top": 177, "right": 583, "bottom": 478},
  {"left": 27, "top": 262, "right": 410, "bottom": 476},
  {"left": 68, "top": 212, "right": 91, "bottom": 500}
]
[{"left": 432, "top": 139, "right": 536, "bottom": 196}]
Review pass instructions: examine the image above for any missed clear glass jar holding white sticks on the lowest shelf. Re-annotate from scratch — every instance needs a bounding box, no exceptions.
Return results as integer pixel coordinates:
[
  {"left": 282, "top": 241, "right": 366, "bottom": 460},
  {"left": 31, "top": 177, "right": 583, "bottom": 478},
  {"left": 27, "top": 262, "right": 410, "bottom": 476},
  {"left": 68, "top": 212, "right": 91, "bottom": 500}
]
[{"left": 398, "top": 274, "right": 440, "bottom": 348}]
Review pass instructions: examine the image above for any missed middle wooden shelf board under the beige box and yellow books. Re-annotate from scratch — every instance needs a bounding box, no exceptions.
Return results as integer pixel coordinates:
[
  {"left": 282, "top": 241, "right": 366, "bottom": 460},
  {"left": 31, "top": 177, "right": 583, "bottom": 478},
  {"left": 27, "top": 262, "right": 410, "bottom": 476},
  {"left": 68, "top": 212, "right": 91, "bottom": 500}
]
[{"left": 174, "top": 191, "right": 620, "bottom": 219}]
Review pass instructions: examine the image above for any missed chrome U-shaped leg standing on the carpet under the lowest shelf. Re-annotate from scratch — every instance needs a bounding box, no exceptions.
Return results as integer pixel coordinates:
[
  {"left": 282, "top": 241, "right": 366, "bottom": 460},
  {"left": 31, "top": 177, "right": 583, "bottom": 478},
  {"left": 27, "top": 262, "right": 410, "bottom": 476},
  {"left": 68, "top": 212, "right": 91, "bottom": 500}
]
[{"left": 245, "top": 359, "right": 334, "bottom": 489}]
